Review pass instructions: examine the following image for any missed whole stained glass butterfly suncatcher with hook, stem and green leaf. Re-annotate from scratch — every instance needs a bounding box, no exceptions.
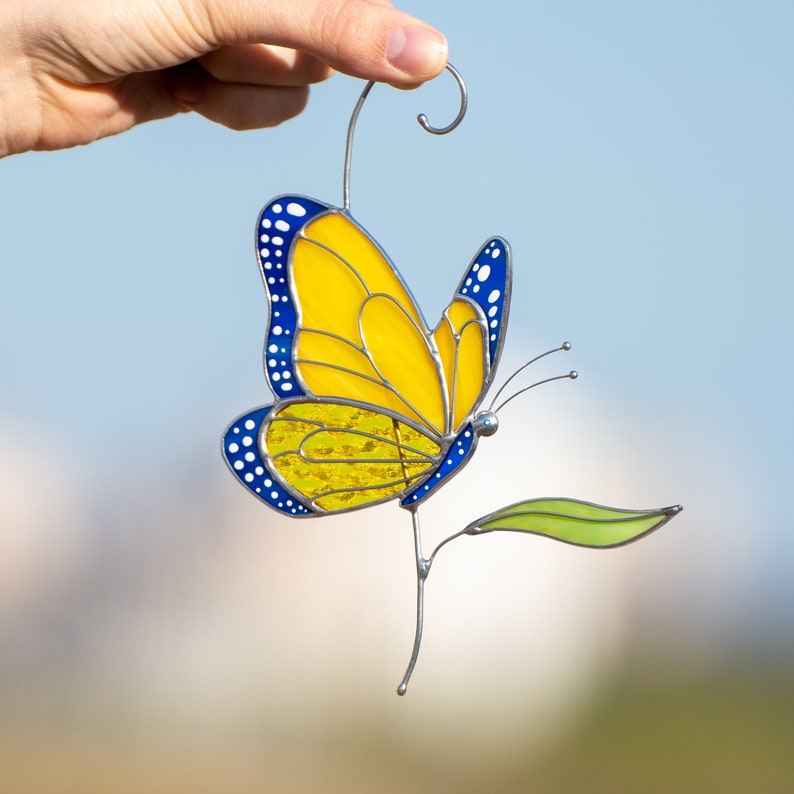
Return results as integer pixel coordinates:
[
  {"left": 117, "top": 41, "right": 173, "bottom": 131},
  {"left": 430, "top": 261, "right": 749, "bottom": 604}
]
[{"left": 223, "top": 66, "right": 681, "bottom": 694}]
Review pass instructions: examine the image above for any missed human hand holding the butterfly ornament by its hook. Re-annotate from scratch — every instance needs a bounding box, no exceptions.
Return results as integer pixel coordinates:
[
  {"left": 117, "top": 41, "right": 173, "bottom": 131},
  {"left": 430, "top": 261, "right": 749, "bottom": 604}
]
[{"left": 0, "top": 0, "right": 447, "bottom": 157}]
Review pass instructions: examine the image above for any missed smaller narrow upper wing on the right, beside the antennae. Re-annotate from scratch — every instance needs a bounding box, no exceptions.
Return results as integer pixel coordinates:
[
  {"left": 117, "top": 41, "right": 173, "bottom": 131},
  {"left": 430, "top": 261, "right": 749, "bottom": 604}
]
[{"left": 433, "top": 237, "right": 512, "bottom": 433}]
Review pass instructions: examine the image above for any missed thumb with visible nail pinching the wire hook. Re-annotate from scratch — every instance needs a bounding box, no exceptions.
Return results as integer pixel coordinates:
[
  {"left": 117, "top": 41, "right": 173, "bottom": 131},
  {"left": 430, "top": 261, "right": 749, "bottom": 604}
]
[{"left": 184, "top": 0, "right": 448, "bottom": 87}]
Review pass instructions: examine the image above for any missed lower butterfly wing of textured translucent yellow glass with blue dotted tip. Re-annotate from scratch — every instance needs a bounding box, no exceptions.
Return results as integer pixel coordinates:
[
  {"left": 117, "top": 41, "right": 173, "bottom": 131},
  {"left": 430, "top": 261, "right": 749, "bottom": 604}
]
[{"left": 223, "top": 400, "right": 442, "bottom": 516}]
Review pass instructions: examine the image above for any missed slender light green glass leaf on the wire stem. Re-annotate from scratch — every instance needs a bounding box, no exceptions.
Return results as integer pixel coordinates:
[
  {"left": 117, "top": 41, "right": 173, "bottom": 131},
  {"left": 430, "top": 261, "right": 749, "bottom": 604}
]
[{"left": 464, "top": 499, "right": 683, "bottom": 549}]
